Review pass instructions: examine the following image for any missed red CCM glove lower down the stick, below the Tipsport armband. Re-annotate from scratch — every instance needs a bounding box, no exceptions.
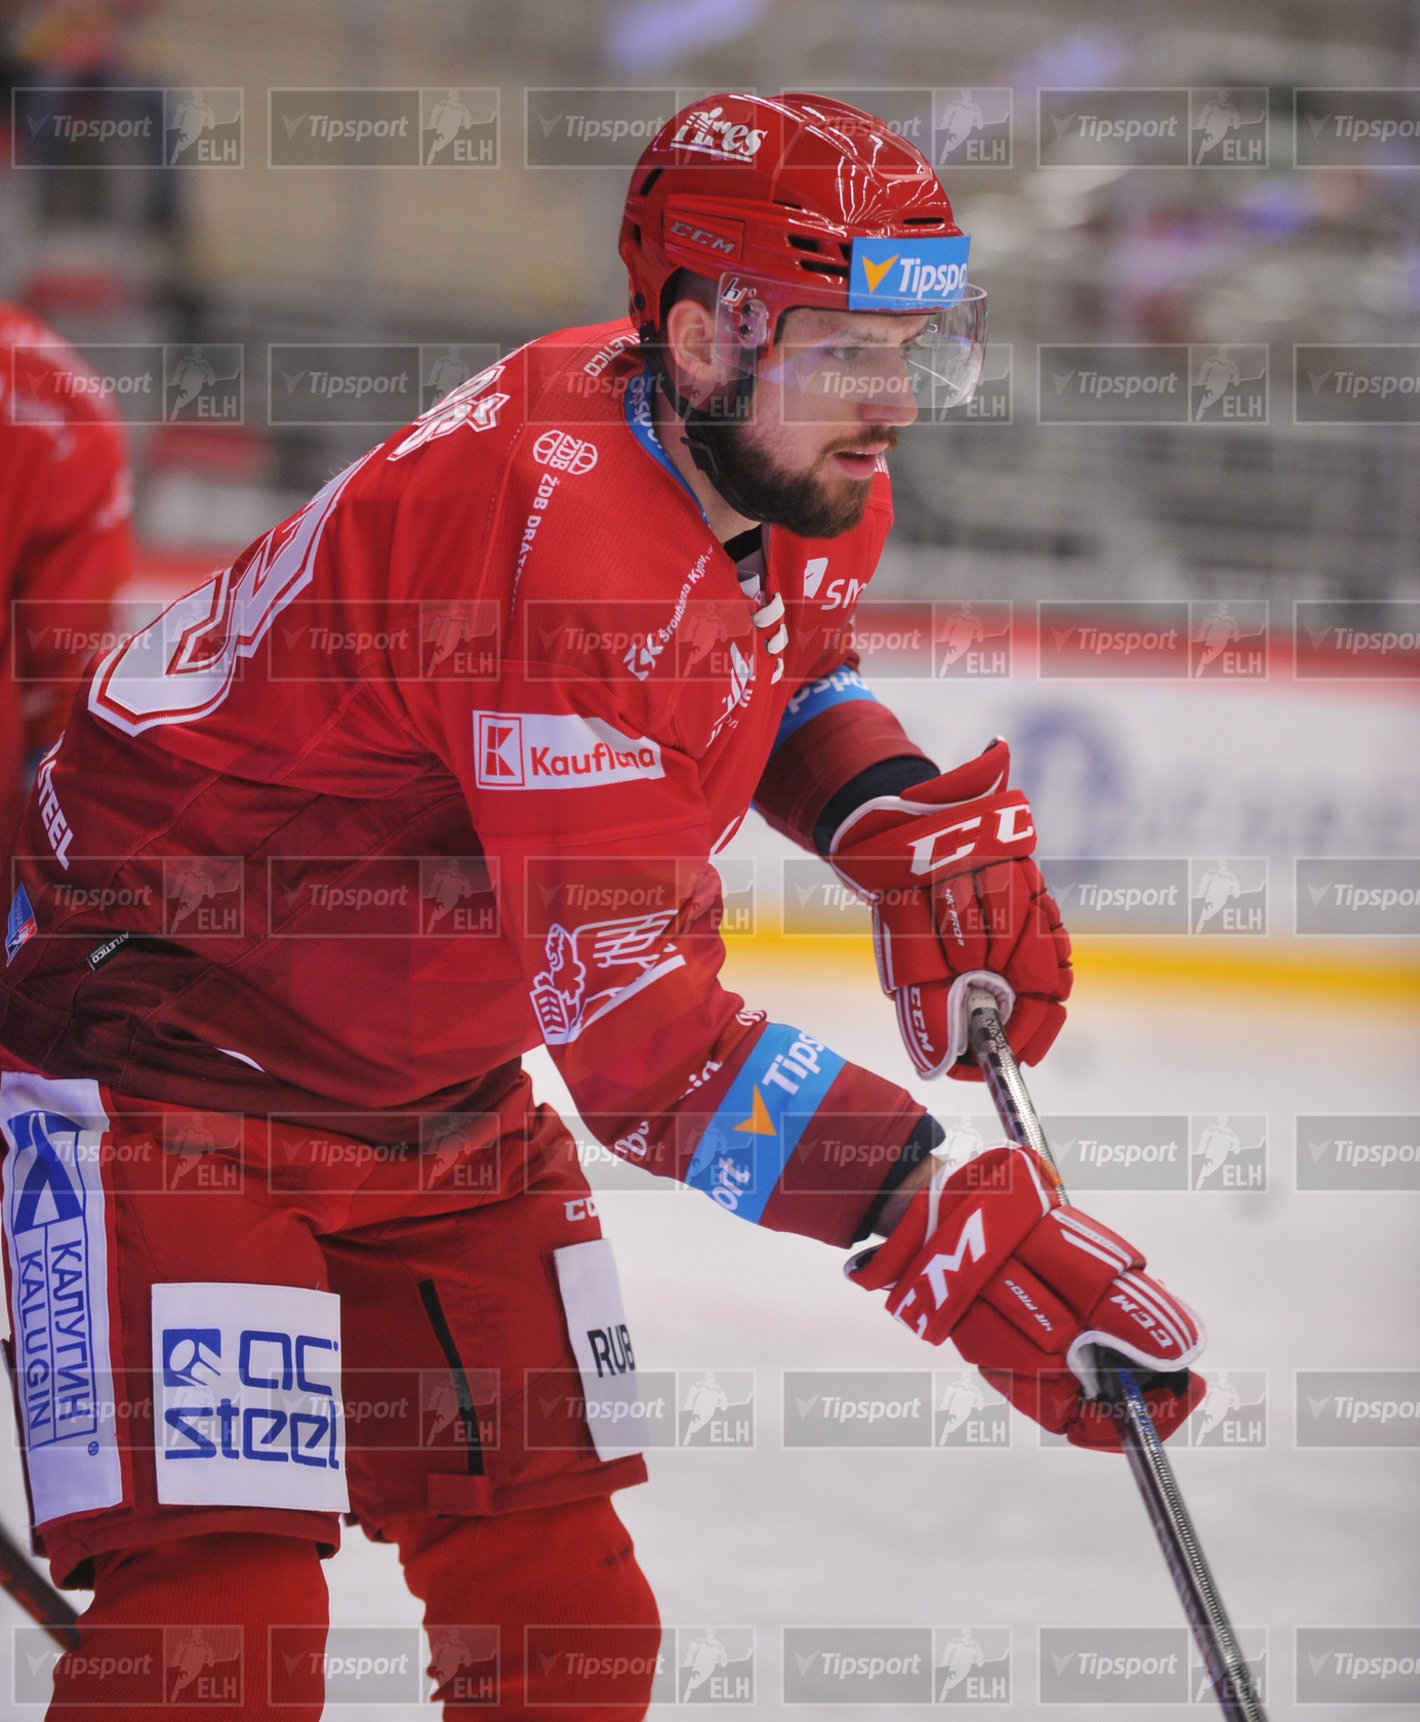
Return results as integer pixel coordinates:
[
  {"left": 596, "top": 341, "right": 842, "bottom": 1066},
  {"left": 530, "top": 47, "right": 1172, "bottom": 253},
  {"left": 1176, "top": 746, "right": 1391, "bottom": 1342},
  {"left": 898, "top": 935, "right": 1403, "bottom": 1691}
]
[{"left": 845, "top": 1147, "right": 1203, "bottom": 1452}]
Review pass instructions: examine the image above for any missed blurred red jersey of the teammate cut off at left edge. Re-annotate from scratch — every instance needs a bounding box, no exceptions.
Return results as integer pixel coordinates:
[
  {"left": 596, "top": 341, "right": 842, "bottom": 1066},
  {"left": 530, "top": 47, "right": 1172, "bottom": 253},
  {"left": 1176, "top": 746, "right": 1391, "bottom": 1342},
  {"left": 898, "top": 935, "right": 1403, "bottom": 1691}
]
[{"left": 0, "top": 301, "right": 133, "bottom": 854}]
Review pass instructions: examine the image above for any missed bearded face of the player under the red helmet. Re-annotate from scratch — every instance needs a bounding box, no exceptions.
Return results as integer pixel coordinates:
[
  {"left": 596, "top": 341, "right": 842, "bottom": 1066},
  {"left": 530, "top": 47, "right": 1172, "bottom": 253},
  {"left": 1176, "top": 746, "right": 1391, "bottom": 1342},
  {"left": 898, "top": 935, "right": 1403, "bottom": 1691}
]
[{"left": 688, "top": 310, "right": 926, "bottom": 537}]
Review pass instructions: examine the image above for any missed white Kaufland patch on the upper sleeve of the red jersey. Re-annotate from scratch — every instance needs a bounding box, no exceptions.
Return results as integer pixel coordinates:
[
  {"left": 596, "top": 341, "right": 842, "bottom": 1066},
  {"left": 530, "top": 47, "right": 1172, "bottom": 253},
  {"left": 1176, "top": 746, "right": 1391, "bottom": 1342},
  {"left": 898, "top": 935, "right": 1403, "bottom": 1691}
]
[{"left": 473, "top": 711, "right": 666, "bottom": 789}]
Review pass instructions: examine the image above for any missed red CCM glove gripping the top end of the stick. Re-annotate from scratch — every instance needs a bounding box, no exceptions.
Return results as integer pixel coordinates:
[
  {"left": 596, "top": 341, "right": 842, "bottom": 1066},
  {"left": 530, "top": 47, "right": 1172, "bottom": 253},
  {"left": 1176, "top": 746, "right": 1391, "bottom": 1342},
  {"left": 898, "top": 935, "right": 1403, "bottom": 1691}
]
[{"left": 828, "top": 740, "right": 1072, "bottom": 1080}]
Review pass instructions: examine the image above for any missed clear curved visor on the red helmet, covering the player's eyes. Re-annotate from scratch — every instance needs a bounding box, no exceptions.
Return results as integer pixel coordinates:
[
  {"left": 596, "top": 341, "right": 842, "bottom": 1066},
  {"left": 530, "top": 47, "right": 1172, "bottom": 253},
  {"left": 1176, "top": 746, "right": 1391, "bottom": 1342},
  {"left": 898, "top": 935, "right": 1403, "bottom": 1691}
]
[{"left": 716, "top": 276, "right": 986, "bottom": 417}]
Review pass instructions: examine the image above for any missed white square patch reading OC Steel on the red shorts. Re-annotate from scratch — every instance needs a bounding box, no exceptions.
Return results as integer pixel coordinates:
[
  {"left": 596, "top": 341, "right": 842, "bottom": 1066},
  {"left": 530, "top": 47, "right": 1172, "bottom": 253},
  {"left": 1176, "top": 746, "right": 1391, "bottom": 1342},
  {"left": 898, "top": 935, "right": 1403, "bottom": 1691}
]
[{"left": 153, "top": 1281, "right": 349, "bottom": 1512}]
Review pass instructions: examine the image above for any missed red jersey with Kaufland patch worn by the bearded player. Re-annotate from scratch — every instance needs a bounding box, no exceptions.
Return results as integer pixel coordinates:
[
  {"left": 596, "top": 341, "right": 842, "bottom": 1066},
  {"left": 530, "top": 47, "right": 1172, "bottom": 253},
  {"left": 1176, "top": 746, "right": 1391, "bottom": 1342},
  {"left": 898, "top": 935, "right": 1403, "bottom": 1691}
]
[{"left": 0, "top": 324, "right": 923, "bottom": 1242}]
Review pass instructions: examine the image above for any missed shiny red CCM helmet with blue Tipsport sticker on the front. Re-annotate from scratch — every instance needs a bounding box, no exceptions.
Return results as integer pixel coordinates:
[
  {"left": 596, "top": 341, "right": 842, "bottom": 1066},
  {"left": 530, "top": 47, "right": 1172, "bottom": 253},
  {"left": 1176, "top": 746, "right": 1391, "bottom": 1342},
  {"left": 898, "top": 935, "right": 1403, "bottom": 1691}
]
[{"left": 620, "top": 95, "right": 966, "bottom": 344}]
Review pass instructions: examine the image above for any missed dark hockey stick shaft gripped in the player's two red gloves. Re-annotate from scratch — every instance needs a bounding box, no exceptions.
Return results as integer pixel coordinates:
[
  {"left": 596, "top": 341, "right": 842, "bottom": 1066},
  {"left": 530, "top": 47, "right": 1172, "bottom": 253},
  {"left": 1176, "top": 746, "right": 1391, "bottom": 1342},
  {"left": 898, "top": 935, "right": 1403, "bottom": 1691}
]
[{"left": 967, "top": 987, "right": 1267, "bottom": 1722}]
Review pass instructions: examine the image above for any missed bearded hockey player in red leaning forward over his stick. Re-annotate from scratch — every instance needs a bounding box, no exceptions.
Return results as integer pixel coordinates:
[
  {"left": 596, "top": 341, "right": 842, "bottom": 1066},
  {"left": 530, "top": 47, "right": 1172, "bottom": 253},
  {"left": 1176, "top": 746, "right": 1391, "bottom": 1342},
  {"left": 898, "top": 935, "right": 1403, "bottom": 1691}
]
[{"left": 0, "top": 95, "right": 1198, "bottom": 1722}]
